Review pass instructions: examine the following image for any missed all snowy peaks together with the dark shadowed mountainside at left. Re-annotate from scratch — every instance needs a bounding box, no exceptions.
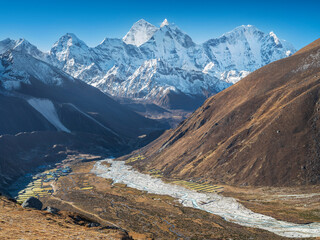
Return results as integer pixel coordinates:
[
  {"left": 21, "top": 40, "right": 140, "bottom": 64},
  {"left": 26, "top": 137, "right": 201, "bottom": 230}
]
[{"left": 0, "top": 20, "right": 295, "bottom": 188}]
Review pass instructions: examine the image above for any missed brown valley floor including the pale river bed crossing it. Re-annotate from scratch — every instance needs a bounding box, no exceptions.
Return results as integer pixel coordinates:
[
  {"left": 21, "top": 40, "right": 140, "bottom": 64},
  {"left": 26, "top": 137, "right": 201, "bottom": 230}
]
[{"left": 5, "top": 155, "right": 320, "bottom": 239}]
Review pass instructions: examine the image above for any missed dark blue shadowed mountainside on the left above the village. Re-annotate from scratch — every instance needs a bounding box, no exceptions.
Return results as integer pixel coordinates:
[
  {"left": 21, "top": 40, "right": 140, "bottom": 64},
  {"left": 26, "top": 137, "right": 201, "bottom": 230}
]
[{"left": 0, "top": 49, "right": 164, "bottom": 188}]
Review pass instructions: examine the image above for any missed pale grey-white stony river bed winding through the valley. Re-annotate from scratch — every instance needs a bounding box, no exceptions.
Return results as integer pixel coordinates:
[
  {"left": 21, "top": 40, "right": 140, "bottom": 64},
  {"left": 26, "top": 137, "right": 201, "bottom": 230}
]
[{"left": 91, "top": 159, "right": 320, "bottom": 238}]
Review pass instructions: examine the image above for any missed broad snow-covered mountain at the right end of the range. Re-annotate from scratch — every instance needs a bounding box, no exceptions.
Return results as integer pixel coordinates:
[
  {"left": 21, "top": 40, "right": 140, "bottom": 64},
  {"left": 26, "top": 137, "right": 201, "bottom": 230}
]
[{"left": 203, "top": 25, "right": 295, "bottom": 72}]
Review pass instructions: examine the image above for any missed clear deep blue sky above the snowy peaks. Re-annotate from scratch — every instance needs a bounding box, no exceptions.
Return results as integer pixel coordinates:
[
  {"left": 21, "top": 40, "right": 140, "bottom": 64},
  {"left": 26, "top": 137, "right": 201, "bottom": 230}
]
[{"left": 0, "top": 0, "right": 320, "bottom": 50}]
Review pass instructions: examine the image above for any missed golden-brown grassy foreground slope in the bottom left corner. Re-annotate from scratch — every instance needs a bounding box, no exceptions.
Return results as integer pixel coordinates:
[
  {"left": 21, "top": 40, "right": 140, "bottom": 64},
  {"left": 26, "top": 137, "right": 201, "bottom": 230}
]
[{"left": 0, "top": 196, "right": 133, "bottom": 240}]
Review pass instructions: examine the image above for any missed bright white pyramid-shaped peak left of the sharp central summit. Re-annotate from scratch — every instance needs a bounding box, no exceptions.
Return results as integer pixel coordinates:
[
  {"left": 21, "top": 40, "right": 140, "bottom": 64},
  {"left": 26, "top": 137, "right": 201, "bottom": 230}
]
[{"left": 122, "top": 19, "right": 158, "bottom": 47}]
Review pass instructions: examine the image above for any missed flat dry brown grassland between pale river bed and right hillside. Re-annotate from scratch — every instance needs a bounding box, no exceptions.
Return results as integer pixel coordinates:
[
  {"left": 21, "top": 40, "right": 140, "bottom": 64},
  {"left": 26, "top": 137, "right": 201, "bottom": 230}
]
[{"left": 223, "top": 186, "right": 320, "bottom": 223}]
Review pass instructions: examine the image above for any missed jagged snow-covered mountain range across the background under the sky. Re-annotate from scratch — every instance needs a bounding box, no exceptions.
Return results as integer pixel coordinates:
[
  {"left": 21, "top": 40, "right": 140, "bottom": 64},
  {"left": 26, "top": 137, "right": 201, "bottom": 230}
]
[{"left": 0, "top": 19, "right": 295, "bottom": 109}]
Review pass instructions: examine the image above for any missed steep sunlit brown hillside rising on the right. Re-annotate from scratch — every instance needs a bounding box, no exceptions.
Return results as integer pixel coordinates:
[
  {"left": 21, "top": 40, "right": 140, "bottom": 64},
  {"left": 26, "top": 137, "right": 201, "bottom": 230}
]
[{"left": 135, "top": 40, "right": 320, "bottom": 186}]
